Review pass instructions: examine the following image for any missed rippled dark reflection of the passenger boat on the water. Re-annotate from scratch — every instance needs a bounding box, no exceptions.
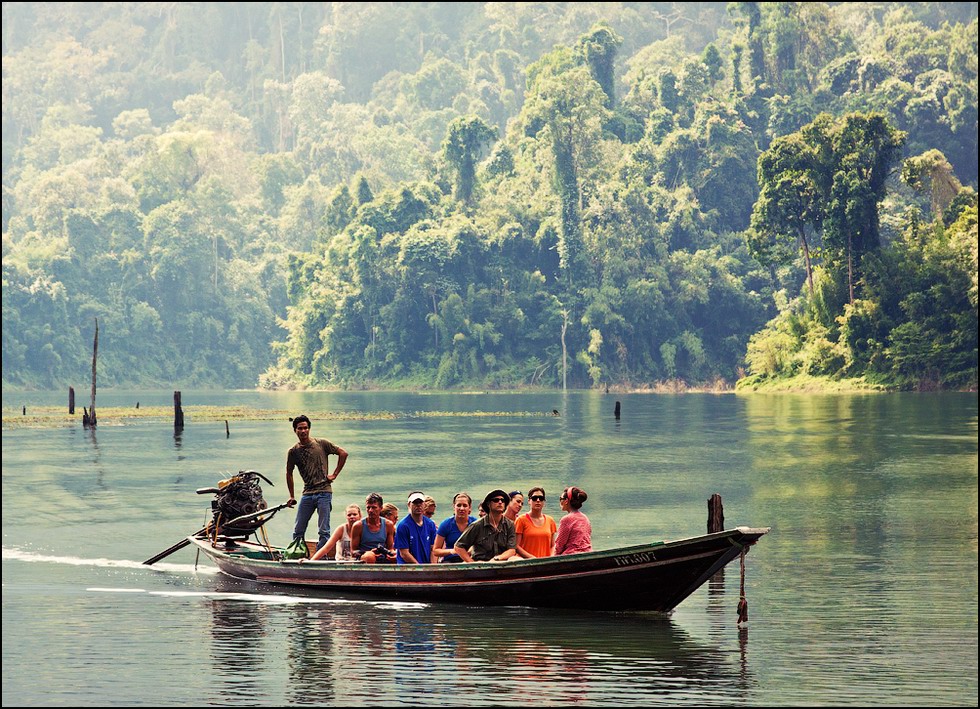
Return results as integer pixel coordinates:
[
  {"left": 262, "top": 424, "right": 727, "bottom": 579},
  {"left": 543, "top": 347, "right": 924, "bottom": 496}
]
[{"left": 203, "top": 577, "right": 753, "bottom": 706}]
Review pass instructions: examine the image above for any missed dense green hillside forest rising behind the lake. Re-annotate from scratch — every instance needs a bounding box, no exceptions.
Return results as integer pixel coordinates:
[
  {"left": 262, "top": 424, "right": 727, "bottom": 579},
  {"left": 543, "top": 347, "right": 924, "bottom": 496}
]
[{"left": 2, "top": 2, "right": 978, "bottom": 390}]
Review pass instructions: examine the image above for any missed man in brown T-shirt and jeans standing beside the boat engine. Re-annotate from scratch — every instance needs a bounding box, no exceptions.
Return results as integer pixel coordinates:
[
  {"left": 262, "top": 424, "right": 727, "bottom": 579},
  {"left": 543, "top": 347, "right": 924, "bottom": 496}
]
[{"left": 286, "top": 414, "right": 347, "bottom": 549}]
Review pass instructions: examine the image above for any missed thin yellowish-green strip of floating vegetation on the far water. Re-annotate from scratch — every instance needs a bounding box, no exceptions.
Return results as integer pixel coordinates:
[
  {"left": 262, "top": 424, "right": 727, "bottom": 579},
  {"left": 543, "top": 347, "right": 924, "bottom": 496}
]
[{"left": 3, "top": 406, "right": 552, "bottom": 429}]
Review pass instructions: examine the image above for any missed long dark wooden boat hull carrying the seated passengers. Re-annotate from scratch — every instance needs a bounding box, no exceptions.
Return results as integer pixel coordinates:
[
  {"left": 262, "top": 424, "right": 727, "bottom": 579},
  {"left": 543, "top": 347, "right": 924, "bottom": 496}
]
[{"left": 188, "top": 527, "right": 769, "bottom": 613}]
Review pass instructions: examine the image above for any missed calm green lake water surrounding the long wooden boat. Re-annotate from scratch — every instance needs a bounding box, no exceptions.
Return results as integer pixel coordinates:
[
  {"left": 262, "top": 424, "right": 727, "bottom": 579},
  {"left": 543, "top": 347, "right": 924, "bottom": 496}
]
[{"left": 2, "top": 391, "right": 978, "bottom": 706}]
